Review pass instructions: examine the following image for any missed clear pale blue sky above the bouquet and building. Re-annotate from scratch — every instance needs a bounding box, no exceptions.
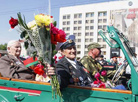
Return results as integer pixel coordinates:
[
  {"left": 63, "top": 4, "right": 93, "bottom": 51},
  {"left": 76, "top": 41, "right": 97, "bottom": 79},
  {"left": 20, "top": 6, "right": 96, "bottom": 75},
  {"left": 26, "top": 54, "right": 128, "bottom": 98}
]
[{"left": 0, "top": 0, "right": 116, "bottom": 44}]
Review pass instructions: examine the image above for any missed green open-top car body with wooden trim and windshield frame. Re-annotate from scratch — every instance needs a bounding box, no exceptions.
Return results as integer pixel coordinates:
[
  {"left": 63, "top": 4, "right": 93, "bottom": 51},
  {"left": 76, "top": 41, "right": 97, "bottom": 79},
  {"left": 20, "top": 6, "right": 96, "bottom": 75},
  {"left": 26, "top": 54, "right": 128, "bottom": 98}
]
[{"left": 0, "top": 26, "right": 138, "bottom": 102}]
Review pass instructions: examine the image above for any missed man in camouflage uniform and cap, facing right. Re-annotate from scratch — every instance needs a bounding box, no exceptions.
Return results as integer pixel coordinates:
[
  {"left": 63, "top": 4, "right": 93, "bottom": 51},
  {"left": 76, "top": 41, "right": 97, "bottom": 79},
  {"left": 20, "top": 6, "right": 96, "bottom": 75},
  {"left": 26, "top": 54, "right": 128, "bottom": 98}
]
[{"left": 80, "top": 42, "right": 103, "bottom": 79}]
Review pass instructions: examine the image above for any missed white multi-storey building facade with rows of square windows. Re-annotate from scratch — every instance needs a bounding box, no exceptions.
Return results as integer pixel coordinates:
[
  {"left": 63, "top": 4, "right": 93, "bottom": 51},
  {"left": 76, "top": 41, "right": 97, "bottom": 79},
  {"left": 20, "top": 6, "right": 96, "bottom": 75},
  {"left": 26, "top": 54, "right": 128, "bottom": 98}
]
[{"left": 59, "top": 0, "right": 138, "bottom": 59}]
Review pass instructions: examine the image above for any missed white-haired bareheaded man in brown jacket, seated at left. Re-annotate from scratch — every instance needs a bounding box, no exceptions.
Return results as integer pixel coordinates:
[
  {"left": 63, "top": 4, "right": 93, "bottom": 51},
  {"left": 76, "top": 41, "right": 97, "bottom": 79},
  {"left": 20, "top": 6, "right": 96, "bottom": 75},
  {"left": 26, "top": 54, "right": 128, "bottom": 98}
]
[{"left": 0, "top": 40, "right": 53, "bottom": 80}]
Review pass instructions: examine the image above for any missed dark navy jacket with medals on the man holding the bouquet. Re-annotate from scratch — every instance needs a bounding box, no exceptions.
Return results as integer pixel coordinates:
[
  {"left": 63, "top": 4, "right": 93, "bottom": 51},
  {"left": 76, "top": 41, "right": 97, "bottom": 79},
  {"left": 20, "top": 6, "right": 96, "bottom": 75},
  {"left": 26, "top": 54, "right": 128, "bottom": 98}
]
[{"left": 56, "top": 57, "right": 92, "bottom": 88}]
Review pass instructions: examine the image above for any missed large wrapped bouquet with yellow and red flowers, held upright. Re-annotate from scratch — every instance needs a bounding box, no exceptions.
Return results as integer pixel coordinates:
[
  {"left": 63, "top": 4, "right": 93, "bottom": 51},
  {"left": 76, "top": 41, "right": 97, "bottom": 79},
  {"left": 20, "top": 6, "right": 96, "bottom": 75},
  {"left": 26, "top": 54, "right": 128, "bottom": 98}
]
[{"left": 9, "top": 13, "right": 66, "bottom": 96}]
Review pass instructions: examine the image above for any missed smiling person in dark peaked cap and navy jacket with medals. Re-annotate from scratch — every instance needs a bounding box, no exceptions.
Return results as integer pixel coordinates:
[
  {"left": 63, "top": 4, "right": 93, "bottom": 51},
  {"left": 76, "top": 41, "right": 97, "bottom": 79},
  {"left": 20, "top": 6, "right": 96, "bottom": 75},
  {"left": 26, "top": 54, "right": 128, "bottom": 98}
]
[{"left": 56, "top": 35, "right": 92, "bottom": 88}]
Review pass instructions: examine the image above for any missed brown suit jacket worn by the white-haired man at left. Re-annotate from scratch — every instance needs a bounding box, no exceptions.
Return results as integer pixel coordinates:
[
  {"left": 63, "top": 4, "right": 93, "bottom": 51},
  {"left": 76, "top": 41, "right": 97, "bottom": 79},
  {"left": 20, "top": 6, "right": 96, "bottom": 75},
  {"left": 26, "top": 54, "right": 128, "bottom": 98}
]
[{"left": 0, "top": 55, "right": 35, "bottom": 80}]
